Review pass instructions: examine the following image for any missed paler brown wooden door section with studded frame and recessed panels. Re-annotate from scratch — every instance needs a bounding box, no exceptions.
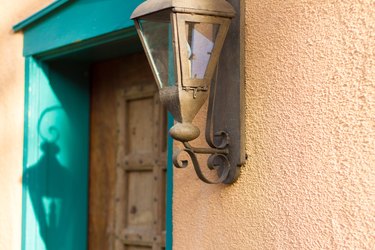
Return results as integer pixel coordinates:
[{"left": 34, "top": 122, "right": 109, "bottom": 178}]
[{"left": 115, "top": 82, "right": 166, "bottom": 250}]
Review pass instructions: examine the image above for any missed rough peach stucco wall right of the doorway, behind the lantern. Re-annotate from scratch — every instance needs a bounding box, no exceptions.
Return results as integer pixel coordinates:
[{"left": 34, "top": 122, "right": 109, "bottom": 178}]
[{"left": 173, "top": 0, "right": 375, "bottom": 250}]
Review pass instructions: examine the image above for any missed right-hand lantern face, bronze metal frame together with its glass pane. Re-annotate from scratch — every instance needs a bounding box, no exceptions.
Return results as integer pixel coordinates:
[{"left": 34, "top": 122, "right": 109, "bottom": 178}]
[{"left": 177, "top": 13, "right": 231, "bottom": 87}]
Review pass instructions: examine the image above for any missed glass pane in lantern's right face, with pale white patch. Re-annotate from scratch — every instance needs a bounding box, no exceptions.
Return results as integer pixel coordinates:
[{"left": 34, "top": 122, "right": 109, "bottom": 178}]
[{"left": 186, "top": 22, "right": 220, "bottom": 79}]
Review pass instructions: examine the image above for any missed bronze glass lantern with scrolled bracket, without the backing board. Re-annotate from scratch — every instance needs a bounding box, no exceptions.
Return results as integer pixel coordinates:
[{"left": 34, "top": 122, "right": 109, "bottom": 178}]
[{"left": 131, "top": 0, "right": 245, "bottom": 183}]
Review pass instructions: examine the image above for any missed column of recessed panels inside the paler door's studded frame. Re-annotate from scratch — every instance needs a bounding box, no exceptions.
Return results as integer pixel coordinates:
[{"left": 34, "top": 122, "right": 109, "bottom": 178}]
[{"left": 120, "top": 91, "right": 157, "bottom": 246}]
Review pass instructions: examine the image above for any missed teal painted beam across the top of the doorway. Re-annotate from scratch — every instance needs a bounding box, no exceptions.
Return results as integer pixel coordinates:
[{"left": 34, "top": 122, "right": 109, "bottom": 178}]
[{"left": 24, "top": 0, "right": 143, "bottom": 56}]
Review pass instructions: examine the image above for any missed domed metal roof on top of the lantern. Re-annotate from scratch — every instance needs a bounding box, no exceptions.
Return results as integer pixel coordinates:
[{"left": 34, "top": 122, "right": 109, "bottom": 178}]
[{"left": 131, "top": 0, "right": 235, "bottom": 19}]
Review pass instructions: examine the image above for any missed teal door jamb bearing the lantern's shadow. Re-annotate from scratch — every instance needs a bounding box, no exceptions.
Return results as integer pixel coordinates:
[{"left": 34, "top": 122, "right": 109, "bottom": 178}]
[{"left": 21, "top": 57, "right": 90, "bottom": 250}]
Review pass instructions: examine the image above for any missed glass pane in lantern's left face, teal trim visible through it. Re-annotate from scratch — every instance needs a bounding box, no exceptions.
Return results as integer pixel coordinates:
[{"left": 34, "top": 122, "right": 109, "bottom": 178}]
[{"left": 139, "top": 14, "right": 176, "bottom": 88}]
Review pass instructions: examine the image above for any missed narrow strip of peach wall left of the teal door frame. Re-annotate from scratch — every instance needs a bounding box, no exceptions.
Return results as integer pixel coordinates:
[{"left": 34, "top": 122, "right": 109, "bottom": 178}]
[{"left": 0, "top": 0, "right": 52, "bottom": 250}]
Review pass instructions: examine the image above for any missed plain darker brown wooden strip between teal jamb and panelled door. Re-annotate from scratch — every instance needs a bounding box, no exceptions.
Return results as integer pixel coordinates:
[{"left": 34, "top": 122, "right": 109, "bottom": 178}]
[{"left": 88, "top": 62, "right": 118, "bottom": 250}]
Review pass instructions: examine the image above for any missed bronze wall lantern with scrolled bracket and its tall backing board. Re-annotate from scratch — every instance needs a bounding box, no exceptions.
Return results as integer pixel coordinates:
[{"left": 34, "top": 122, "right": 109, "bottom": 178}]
[{"left": 131, "top": 0, "right": 246, "bottom": 184}]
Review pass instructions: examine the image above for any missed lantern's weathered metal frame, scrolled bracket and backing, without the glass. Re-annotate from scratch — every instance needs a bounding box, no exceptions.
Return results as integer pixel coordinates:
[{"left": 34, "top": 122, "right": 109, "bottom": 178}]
[{"left": 132, "top": 0, "right": 245, "bottom": 184}]
